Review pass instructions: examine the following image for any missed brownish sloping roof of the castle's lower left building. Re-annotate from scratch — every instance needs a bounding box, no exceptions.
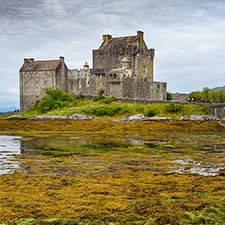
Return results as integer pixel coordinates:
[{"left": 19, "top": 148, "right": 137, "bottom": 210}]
[{"left": 20, "top": 60, "right": 61, "bottom": 72}]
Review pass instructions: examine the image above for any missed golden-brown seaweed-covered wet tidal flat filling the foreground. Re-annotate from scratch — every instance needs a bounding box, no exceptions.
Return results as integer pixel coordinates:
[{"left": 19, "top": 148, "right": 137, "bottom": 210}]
[{"left": 0, "top": 120, "right": 225, "bottom": 224}]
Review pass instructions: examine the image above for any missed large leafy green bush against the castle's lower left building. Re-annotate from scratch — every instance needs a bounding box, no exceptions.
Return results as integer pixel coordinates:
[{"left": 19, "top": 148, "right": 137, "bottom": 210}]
[{"left": 34, "top": 88, "right": 75, "bottom": 113}]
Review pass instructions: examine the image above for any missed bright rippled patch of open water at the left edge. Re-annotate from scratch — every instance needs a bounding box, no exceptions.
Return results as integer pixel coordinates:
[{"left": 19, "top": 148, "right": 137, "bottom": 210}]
[{"left": 0, "top": 136, "right": 21, "bottom": 174}]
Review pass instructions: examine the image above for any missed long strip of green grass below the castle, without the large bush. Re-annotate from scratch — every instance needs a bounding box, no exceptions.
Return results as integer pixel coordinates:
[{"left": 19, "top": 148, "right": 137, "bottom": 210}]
[{"left": 20, "top": 97, "right": 206, "bottom": 119}]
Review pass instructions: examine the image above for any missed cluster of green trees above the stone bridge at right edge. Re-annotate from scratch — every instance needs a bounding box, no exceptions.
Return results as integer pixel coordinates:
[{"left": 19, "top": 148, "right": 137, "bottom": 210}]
[{"left": 189, "top": 87, "right": 225, "bottom": 103}]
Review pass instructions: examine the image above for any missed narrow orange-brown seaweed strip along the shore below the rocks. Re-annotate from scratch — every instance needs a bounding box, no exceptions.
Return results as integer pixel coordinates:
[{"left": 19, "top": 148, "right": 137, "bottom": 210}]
[{"left": 0, "top": 119, "right": 225, "bottom": 135}]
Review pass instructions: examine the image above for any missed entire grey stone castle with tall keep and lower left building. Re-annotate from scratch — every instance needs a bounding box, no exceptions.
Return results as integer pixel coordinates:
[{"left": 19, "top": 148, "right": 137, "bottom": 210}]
[{"left": 19, "top": 31, "right": 166, "bottom": 111}]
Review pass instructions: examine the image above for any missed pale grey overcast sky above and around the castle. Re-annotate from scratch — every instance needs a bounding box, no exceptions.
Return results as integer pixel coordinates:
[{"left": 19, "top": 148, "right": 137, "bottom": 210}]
[{"left": 0, "top": 0, "right": 225, "bottom": 108}]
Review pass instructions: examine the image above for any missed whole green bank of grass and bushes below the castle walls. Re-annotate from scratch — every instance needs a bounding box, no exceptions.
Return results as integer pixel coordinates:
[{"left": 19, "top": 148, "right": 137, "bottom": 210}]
[{"left": 20, "top": 89, "right": 210, "bottom": 119}]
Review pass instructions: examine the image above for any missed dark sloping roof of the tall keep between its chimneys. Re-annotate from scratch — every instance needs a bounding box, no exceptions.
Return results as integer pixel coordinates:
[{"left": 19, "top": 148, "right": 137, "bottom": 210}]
[{"left": 99, "top": 36, "right": 138, "bottom": 50}]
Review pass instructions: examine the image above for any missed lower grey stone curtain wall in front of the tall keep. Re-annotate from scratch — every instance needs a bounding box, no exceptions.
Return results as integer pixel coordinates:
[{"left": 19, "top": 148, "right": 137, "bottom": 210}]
[{"left": 68, "top": 70, "right": 166, "bottom": 101}]
